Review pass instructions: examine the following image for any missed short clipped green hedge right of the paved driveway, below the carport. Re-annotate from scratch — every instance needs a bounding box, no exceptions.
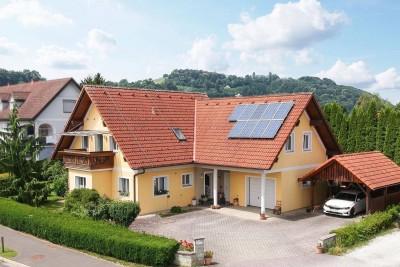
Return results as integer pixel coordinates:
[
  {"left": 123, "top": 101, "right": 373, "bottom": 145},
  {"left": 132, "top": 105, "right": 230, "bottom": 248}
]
[{"left": 331, "top": 205, "right": 400, "bottom": 249}]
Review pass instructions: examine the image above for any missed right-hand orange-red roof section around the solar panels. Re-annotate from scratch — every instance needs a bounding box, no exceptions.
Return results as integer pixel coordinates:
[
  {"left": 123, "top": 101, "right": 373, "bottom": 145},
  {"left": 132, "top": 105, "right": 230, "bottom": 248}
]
[{"left": 194, "top": 93, "right": 340, "bottom": 170}]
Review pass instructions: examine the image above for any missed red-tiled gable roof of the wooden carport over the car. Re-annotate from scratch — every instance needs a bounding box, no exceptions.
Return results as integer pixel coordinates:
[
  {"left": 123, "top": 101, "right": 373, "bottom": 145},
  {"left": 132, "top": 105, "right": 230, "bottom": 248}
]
[{"left": 300, "top": 151, "right": 400, "bottom": 190}]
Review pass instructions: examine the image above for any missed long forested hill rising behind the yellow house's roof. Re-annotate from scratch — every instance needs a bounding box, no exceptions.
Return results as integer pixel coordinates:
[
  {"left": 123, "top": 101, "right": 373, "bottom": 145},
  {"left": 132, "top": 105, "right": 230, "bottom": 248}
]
[{"left": 105, "top": 69, "right": 365, "bottom": 112}]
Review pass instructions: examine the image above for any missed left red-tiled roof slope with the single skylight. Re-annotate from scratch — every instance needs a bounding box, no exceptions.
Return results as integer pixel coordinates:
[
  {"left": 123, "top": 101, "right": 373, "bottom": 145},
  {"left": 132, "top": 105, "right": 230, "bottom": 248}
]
[{"left": 85, "top": 87, "right": 206, "bottom": 168}]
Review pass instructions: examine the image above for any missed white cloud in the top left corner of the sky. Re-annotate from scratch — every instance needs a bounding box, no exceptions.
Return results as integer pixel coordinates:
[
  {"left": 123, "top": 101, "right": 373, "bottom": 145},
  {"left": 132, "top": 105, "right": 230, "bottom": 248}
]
[{"left": 0, "top": 0, "right": 73, "bottom": 26}]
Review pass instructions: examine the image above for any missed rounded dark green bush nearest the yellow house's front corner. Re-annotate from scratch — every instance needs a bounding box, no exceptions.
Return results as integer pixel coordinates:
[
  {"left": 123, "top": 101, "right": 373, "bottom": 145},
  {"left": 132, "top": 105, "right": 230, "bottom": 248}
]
[{"left": 108, "top": 201, "right": 140, "bottom": 227}]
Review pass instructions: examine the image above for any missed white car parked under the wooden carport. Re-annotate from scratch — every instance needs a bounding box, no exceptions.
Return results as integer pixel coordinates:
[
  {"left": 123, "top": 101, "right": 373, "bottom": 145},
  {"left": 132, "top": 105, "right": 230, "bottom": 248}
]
[{"left": 324, "top": 190, "right": 365, "bottom": 217}]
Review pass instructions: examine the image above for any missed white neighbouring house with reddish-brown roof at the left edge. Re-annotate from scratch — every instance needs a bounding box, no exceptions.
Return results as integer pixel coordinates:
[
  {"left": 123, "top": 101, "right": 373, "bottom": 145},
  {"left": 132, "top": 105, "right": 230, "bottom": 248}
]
[{"left": 0, "top": 78, "right": 80, "bottom": 159}]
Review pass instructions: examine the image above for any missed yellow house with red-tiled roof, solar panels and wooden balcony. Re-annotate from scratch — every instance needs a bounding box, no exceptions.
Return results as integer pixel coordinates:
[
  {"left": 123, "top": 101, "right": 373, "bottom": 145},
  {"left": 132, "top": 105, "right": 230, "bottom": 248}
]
[{"left": 53, "top": 86, "right": 341, "bottom": 216}]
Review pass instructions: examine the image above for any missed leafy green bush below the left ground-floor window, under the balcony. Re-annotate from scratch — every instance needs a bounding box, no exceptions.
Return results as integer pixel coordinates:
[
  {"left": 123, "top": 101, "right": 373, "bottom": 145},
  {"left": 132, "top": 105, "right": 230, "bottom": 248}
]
[{"left": 64, "top": 188, "right": 100, "bottom": 211}]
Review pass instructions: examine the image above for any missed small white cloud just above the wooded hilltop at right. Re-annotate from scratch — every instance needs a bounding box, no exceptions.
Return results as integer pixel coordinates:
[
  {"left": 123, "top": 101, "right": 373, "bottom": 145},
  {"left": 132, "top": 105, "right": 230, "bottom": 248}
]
[{"left": 316, "top": 59, "right": 375, "bottom": 86}]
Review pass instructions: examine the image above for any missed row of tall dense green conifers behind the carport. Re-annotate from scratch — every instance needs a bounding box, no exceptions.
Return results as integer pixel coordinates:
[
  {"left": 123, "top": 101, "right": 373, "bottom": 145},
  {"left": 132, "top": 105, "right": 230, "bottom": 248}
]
[{"left": 324, "top": 95, "right": 400, "bottom": 165}]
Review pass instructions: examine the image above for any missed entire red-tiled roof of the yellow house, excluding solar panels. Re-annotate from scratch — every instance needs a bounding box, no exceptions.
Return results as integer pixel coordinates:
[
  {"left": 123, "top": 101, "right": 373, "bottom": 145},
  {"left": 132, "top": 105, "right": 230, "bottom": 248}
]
[{"left": 53, "top": 86, "right": 341, "bottom": 172}]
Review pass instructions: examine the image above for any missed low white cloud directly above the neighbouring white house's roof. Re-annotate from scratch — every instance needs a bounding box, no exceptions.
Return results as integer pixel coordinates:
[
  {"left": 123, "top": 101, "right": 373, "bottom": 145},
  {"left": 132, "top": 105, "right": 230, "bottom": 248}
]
[{"left": 36, "top": 45, "right": 89, "bottom": 69}]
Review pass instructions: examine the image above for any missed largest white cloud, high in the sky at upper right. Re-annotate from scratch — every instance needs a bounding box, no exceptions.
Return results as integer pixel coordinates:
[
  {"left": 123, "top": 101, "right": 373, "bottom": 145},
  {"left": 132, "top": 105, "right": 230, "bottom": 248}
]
[{"left": 224, "top": 0, "right": 348, "bottom": 64}]
